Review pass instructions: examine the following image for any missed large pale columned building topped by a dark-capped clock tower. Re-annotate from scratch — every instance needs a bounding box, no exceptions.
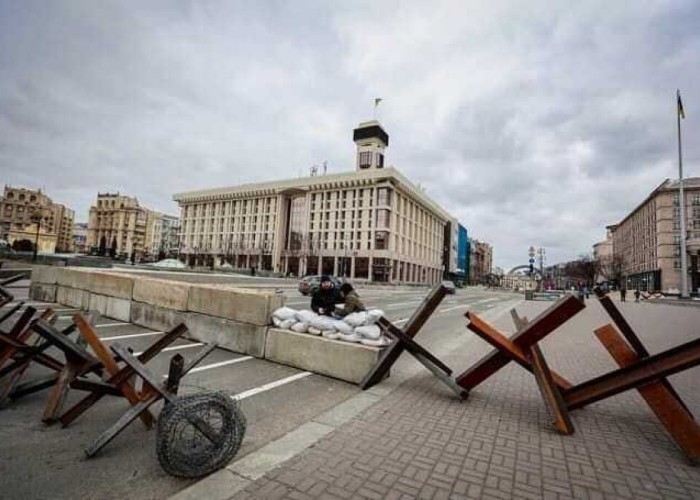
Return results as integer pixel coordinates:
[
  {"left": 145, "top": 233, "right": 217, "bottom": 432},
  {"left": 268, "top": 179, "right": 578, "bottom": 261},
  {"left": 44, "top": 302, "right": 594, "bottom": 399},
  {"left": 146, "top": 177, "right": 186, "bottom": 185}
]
[{"left": 173, "top": 121, "right": 457, "bottom": 283}]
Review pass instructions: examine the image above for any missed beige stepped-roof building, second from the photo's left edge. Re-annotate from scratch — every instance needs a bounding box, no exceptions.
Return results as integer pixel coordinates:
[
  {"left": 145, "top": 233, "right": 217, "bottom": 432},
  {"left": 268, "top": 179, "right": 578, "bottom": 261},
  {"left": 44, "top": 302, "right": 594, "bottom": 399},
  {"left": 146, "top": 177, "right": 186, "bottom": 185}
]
[{"left": 87, "top": 193, "right": 149, "bottom": 259}]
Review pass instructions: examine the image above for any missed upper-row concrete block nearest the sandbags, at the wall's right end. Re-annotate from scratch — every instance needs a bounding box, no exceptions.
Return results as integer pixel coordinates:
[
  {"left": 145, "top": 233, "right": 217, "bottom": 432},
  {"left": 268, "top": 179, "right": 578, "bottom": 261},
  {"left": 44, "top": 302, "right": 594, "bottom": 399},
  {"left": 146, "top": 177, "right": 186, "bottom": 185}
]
[{"left": 187, "top": 285, "right": 277, "bottom": 326}]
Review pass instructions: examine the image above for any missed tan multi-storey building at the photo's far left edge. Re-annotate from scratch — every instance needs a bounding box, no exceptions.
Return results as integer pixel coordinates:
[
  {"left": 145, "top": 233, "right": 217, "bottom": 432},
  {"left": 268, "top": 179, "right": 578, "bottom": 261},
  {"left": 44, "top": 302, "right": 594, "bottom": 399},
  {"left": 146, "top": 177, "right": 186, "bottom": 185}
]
[{"left": 0, "top": 186, "right": 75, "bottom": 253}]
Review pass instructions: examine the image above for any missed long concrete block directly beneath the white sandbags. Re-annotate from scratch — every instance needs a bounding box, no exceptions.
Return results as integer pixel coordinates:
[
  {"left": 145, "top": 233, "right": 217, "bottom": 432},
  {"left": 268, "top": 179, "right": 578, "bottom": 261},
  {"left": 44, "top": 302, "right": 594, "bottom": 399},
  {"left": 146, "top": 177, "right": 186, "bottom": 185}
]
[{"left": 265, "top": 328, "right": 382, "bottom": 384}]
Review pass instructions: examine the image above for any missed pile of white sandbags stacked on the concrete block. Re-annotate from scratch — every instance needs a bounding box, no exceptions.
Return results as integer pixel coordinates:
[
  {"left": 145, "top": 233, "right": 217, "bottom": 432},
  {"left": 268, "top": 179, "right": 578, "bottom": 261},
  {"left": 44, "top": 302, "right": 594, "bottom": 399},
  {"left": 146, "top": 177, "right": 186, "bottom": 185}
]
[{"left": 272, "top": 307, "right": 390, "bottom": 347}]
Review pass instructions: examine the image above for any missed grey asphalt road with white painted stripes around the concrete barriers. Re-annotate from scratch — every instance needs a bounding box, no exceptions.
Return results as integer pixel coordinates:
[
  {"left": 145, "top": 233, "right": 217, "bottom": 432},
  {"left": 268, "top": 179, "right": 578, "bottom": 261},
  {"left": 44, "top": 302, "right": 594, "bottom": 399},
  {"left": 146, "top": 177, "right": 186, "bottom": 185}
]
[{"left": 0, "top": 273, "right": 519, "bottom": 499}]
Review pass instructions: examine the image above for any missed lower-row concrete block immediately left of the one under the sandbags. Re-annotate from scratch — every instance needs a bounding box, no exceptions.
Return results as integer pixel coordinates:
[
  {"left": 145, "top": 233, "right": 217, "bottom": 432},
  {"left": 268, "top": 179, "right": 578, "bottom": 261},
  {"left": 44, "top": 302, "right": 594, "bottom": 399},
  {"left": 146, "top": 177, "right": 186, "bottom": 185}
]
[{"left": 185, "top": 312, "right": 267, "bottom": 358}]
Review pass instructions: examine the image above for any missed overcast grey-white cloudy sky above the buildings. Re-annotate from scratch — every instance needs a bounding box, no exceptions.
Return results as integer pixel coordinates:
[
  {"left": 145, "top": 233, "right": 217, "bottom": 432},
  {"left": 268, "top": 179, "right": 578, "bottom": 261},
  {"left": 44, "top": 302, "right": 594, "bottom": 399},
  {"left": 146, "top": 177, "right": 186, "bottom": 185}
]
[{"left": 0, "top": 0, "right": 700, "bottom": 268}]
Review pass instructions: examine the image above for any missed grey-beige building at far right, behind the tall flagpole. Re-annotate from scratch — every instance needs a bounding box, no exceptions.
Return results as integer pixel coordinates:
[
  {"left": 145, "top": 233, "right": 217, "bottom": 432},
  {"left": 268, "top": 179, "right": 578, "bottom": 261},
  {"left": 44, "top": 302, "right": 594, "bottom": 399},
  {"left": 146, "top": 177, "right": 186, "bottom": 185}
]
[{"left": 608, "top": 177, "right": 700, "bottom": 292}]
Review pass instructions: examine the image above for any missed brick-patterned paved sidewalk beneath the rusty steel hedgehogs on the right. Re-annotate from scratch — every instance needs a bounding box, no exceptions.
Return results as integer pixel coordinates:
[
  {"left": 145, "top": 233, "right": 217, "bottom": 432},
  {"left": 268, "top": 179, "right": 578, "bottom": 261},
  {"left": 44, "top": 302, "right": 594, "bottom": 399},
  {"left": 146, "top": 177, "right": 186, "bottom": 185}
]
[{"left": 226, "top": 300, "right": 700, "bottom": 499}]
